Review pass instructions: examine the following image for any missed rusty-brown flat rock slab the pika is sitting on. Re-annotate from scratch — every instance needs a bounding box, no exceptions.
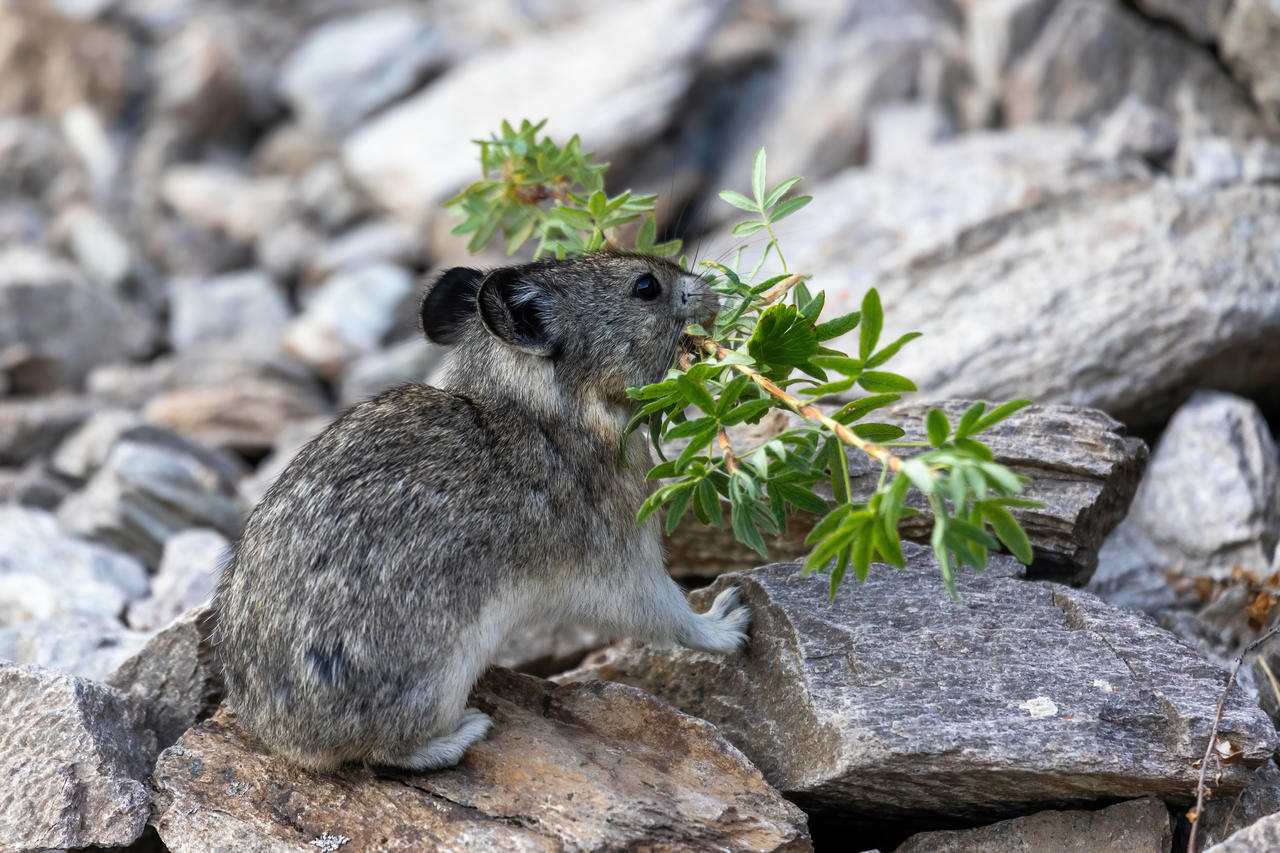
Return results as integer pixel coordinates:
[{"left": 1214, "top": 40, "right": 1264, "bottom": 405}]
[{"left": 152, "top": 670, "right": 812, "bottom": 853}]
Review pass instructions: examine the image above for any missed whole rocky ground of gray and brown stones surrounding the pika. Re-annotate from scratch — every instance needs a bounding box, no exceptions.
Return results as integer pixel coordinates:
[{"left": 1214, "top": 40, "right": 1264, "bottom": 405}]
[{"left": 0, "top": 0, "right": 1280, "bottom": 853}]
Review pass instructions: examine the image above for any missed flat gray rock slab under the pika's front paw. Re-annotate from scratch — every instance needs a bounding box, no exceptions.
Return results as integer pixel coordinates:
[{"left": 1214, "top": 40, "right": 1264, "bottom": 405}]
[{"left": 557, "top": 543, "right": 1276, "bottom": 829}]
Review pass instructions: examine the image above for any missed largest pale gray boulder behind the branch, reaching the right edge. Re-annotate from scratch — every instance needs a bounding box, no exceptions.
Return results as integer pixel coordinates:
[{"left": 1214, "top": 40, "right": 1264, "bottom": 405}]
[{"left": 703, "top": 127, "right": 1280, "bottom": 429}]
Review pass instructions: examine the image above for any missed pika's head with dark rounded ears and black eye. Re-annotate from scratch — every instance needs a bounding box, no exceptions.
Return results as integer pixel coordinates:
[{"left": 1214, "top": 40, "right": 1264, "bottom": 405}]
[{"left": 421, "top": 252, "right": 719, "bottom": 401}]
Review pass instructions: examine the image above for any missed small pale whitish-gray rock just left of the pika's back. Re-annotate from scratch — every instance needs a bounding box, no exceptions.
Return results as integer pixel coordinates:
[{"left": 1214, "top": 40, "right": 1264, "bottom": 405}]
[{"left": 127, "top": 528, "right": 230, "bottom": 630}]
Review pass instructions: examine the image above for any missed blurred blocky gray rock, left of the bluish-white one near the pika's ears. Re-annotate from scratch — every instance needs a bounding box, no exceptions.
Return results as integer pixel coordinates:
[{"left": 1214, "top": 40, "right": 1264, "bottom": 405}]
[{"left": 169, "top": 270, "right": 291, "bottom": 353}]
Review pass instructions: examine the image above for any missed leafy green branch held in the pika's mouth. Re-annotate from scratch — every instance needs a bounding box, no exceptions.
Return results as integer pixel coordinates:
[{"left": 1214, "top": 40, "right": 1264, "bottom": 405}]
[{"left": 447, "top": 120, "right": 1038, "bottom": 596}]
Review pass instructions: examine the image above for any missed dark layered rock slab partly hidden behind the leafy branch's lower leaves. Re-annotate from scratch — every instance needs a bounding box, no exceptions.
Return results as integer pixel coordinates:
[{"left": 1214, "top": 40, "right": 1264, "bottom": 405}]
[{"left": 667, "top": 400, "right": 1147, "bottom": 583}]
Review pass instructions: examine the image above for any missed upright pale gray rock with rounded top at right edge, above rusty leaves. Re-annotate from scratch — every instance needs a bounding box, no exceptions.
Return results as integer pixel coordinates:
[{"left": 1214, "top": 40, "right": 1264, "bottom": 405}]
[{"left": 1089, "top": 392, "right": 1280, "bottom": 612}]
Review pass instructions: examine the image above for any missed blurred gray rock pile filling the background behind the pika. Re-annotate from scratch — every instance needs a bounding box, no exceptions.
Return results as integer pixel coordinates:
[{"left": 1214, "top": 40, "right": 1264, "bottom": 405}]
[{"left": 0, "top": 0, "right": 1280, "bottom": 849}]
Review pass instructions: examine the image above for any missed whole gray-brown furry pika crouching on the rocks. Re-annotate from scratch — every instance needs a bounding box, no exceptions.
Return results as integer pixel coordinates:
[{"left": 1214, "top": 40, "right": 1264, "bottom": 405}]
[{"left": 215, "top": 252, "right": 750, "bottom": 771}]
